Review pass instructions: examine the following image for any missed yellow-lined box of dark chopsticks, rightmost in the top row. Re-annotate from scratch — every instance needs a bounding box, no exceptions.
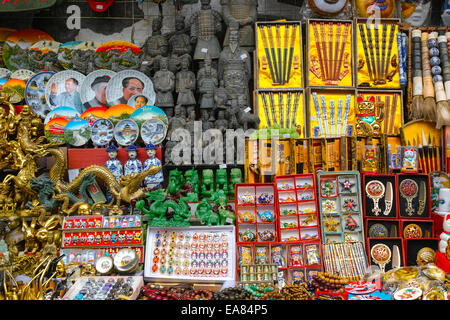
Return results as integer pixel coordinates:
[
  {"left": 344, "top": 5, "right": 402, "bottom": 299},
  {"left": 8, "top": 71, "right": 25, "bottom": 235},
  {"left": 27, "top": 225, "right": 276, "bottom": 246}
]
[{"left": 355, "top": 19, "right": 400, "bottom": 89}]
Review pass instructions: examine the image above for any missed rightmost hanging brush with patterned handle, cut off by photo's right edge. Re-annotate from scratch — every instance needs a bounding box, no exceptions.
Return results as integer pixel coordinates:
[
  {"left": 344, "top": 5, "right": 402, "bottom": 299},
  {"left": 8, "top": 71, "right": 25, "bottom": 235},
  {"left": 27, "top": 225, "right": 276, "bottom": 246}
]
[{"left": 436, "top": 32, "right": 450, "bottom": 129}]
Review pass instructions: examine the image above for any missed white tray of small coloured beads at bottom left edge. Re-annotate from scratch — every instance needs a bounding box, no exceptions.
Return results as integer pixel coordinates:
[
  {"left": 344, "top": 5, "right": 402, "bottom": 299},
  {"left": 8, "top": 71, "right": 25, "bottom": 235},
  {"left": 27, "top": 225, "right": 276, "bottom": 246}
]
[{"left": 63, "top": 276, "right": 144, "bottom": 300}]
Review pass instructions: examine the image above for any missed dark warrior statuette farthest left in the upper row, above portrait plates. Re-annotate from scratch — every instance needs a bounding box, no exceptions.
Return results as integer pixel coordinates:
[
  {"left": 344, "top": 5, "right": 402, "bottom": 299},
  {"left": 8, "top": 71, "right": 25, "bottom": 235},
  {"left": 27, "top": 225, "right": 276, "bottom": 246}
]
[{"left": 141, "top": 16, "right": 169, "bottom": 76}]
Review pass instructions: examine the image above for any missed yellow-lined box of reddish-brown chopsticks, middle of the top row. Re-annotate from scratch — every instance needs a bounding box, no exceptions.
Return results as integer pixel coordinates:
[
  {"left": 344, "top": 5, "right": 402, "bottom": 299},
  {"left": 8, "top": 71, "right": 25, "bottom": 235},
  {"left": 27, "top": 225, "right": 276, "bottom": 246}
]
[{"left": 305, "top": 19, "right": 355, "bottom": 87}]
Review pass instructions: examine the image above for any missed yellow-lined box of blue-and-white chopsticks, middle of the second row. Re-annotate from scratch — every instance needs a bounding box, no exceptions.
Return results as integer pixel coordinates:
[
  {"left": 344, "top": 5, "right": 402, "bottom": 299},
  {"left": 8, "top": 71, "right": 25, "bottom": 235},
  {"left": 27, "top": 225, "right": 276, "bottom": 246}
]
[{"left": 305, "top": 87, "right": 356, "bottom": 139}]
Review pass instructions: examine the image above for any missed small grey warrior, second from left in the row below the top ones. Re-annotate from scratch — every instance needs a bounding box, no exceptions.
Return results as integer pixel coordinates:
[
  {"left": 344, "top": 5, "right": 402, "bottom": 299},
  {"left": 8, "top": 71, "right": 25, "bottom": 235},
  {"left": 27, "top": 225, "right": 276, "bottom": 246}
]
[{"left": 176, "top": 57, "right": 196, "bottom": 117}]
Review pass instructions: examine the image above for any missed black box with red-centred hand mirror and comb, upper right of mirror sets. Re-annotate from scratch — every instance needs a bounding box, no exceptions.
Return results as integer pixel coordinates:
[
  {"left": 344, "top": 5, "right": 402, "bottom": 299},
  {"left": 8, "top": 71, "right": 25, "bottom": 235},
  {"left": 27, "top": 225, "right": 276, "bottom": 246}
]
[{"left": 396, "top": 173, "right": 431, "bottom": 219}]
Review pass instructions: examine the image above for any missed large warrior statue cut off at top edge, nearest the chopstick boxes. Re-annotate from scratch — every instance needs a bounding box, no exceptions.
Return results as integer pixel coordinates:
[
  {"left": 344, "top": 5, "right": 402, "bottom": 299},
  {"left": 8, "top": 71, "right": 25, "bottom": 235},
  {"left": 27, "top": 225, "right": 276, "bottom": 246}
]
[{"left": 221, "top": 0, "right": 258, "bottom": 52}]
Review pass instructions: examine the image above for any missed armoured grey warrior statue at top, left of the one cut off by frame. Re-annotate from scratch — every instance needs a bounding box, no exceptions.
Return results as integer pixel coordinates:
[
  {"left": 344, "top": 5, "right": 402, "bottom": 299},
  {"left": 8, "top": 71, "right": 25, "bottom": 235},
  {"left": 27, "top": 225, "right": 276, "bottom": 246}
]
[{"left": 190, "top": 0, "right": 222, "bottom": 60}]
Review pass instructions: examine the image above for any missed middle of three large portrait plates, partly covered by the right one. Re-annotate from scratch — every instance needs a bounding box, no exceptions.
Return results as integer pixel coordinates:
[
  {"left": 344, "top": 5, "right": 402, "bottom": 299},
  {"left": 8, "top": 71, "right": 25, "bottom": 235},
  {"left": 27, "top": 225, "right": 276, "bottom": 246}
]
[{"left": 80, "top": 70, "right": 116, "bottom": 109}]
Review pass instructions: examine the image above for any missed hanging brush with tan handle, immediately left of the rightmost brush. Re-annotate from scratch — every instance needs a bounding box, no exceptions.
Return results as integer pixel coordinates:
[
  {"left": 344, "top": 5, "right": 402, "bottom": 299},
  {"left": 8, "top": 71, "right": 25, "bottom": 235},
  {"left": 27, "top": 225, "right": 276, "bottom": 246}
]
[{"left": 421, "top": 32, "right": 439, "bottom": 121}]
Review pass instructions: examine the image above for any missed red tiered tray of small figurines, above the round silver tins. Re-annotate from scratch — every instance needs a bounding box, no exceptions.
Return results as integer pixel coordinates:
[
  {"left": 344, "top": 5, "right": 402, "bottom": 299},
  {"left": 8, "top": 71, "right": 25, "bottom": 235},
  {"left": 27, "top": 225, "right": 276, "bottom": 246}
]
[{"left": 60, "top": 215, "right": 144, "bottom": 268}]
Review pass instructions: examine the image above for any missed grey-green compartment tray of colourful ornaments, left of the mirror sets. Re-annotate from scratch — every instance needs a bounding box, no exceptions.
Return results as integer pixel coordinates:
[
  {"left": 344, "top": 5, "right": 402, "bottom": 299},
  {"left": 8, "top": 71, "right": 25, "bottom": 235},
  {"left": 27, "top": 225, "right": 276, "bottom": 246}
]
[{"left": 317, "top": 171, "right": 364, "bottom": 244}]
